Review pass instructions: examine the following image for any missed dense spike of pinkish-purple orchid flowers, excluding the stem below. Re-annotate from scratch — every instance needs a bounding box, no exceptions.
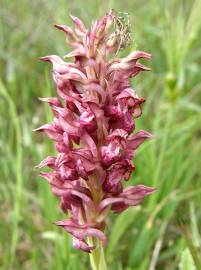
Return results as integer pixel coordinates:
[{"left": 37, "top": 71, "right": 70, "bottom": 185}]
[{"left": 36, "top": 11, "right": 154, "bottom": 252}]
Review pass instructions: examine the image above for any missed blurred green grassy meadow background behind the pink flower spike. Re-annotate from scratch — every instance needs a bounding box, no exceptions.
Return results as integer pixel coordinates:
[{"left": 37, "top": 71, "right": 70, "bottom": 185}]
[{"left": 0, "top": 0, "right": 201, "bottom": 270}]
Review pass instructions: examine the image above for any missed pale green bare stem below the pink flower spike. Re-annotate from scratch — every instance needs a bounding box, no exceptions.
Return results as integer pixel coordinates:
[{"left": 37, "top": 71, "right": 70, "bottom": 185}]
[{"left": 89, "top": 238, "right": 107, "bottom": 270}]
